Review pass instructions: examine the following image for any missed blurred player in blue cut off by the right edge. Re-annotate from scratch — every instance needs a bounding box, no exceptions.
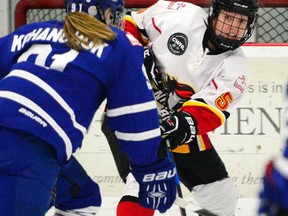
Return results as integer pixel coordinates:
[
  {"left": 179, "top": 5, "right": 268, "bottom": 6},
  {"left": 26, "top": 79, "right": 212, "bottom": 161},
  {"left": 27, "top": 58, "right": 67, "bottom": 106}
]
[{"left": 259, "top": 82, "right": 288, "bottom": 216}]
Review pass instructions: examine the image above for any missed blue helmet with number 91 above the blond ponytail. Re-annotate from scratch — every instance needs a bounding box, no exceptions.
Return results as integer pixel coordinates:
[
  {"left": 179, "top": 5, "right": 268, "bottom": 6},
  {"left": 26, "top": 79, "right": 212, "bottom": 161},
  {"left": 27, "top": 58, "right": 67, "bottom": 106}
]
[{"left": 65, "top": 0, "right": 124, "bottom": 27}]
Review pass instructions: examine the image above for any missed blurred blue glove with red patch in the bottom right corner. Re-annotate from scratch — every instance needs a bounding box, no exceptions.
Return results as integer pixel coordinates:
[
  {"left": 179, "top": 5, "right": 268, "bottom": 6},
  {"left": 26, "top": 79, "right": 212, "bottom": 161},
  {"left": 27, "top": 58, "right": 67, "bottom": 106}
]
[{"left": 259, "top": 157, "right": 288, "bottom": 216}]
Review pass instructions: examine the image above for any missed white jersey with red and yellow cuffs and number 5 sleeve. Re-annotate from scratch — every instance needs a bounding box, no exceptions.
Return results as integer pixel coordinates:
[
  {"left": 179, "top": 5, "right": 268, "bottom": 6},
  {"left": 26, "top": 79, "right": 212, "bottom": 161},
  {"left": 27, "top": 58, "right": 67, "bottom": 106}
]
[{"left": 126, "top": 1, "right": 247, "bottom": 152}]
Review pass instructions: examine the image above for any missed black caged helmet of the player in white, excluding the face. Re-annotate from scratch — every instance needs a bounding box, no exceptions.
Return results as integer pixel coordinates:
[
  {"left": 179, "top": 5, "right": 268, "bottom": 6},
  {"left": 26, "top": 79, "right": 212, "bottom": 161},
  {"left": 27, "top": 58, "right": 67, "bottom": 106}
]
[{"left": 207, "top": 0, "right": 258, "bottom": 50}]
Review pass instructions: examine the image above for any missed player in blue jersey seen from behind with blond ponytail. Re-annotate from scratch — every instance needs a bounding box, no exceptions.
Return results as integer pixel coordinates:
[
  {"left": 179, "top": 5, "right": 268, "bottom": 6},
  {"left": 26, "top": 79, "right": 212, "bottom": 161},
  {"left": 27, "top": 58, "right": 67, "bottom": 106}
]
[{"left": 0, "top": 0, "right": 176, "bottom": 216}]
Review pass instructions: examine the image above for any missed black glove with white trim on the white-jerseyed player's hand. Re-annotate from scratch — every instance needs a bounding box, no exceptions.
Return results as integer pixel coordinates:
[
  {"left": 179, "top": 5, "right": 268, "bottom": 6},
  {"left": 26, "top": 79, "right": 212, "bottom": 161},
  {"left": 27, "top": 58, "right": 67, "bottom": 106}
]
[{"left": 160, "top": 112, "right": 197, "bottom": 150}]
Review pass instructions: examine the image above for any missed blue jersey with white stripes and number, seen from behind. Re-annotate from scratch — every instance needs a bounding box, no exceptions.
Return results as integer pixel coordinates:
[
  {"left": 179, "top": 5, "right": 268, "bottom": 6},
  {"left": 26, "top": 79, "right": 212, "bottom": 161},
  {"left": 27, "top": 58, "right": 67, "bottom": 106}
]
[{"left": 0, "top": 21, "right": 161, "bottom": 166}]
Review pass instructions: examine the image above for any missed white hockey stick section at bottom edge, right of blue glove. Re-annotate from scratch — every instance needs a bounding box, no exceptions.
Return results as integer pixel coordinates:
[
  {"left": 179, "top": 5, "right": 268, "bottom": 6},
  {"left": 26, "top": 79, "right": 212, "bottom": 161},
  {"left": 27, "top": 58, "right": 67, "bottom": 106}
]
[{"left": 174, "top": 197, "right": 218, "bottom": 216}]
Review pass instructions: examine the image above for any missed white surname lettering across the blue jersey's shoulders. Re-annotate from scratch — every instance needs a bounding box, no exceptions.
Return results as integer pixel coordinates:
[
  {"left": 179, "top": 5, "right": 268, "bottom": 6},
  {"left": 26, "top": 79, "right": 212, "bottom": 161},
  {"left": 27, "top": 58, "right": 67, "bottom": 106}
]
[{"left": 11, "top": 27, "right": 108, "bottom": 58}]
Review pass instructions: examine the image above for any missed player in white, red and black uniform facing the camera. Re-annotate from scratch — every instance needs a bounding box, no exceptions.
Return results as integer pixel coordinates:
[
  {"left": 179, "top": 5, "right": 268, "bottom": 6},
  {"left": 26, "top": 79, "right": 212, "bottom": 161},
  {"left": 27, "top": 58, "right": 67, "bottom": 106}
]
[{"left": 103, "top": 0, "right": 258, "bottom": 216}]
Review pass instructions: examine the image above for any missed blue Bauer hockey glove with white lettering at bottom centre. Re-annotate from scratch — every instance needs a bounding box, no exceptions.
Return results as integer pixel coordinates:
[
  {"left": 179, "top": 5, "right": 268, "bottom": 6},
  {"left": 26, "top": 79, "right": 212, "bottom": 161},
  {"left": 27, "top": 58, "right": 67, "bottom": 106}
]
[{"left": 132, "top": 158, "right": 176, "bottom": 213}]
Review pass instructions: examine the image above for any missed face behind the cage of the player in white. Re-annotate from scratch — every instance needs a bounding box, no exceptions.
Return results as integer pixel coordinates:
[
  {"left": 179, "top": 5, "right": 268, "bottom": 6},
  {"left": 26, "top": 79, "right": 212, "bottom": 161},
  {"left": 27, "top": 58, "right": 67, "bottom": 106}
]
[{"left": 214, "top": 10, "right": 248, "bottom": 40}]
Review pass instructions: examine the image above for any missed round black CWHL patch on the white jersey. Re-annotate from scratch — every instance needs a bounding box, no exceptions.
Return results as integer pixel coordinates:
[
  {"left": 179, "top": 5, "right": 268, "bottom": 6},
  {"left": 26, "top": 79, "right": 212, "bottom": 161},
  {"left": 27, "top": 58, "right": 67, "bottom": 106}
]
[{"left": 167, "top": 33, "right": 188, "bottom": 55}]
